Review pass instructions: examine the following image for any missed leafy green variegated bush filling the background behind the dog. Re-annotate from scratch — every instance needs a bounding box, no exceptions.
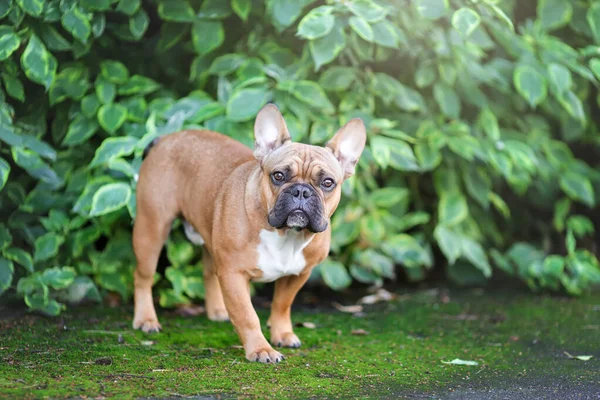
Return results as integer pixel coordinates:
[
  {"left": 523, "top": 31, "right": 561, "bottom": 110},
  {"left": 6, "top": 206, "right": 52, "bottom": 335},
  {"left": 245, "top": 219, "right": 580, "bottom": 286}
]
[{"left": 0, "top": 0, "right": 600, "bottom": 315}]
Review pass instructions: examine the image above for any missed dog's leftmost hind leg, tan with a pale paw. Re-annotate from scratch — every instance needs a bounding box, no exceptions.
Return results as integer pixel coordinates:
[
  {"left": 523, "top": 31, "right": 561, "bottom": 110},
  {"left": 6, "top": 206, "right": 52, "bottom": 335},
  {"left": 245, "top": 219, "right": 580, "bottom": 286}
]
[{"left": 133, "top": 202, "right": 175, "bottom": 332}]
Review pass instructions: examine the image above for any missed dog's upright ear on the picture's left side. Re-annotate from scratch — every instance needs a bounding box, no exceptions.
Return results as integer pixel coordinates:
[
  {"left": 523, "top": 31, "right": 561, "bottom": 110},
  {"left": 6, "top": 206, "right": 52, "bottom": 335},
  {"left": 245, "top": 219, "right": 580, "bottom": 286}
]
[{"left": 254, "top": 104, "right": 292, "bottom": 162}]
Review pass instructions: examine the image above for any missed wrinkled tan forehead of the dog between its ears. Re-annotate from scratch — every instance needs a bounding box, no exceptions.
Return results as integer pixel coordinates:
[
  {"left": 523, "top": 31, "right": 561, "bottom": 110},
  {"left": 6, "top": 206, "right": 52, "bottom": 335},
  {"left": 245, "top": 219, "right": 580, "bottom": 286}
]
[{"left": 263, "top": 143, "right": 343, "bottom": 180}]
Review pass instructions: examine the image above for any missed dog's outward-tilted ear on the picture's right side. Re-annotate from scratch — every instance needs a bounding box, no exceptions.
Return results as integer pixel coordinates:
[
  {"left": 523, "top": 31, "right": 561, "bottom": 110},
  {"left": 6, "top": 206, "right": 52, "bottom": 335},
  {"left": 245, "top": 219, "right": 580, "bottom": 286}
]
[{"left": 326, "top": 118, "right": 367, "bottom": 179}]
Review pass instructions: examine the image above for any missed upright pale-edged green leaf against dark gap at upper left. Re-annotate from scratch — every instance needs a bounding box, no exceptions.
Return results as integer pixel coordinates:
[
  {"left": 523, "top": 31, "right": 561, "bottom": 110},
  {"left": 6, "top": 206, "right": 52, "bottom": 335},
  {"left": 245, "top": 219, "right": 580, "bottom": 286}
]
[{"left": 21, "top": 35, "right": 57, "bottom": 89}]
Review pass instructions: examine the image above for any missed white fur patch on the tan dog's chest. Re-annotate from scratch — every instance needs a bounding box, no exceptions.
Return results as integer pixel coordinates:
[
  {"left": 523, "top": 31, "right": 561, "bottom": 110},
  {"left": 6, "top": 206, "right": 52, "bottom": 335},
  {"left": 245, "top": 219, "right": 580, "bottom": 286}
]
[{"left": 257, "top": 229, "right": 314, "bottom": 282}]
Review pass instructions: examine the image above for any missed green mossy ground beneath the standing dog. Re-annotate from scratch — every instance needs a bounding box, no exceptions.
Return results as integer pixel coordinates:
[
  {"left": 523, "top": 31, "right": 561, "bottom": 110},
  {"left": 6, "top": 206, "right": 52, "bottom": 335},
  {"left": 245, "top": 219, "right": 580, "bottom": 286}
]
[{"left": 0, "top": 289, "right": 600, "bottom": 399}]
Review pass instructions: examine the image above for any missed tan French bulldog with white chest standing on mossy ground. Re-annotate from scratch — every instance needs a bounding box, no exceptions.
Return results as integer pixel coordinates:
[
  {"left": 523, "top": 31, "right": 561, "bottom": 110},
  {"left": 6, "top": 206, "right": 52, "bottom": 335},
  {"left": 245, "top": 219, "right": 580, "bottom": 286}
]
[{"left": 133, "top": 104, "right": 366, "bottom": 363}]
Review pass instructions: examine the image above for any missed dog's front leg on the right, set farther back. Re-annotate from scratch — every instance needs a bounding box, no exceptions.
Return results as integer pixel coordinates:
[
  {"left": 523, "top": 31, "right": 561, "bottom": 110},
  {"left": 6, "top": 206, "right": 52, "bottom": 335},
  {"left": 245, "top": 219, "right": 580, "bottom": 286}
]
[{"left": 268, "top": 271, "right": 310, "bottom": 347}]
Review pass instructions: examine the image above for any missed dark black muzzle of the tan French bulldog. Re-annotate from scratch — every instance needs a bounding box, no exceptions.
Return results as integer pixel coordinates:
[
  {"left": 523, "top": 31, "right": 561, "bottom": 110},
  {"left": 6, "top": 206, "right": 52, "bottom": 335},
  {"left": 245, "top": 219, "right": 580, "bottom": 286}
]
[{"left": 269, "top": 183, "right": 327, "bottom": 233}]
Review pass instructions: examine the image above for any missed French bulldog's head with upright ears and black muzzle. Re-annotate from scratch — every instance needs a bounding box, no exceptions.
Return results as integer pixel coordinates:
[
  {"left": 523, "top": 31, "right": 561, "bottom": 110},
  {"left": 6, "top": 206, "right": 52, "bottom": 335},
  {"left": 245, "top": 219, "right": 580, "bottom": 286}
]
[{"left": 254, "top": 104, "right": 366, "bottom": 232}]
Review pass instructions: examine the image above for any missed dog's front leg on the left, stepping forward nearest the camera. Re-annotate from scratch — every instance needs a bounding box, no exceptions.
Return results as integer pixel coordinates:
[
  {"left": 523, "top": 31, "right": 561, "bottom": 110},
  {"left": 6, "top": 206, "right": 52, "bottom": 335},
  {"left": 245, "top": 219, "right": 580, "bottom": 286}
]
[{"left": 219, "top": 271, "right": 283, "bottom": 363}]
